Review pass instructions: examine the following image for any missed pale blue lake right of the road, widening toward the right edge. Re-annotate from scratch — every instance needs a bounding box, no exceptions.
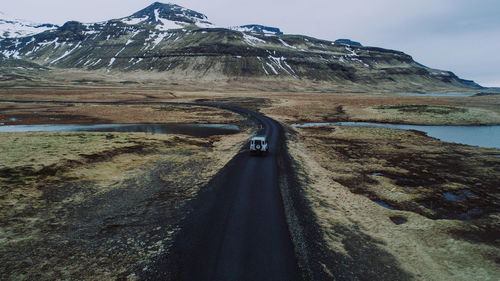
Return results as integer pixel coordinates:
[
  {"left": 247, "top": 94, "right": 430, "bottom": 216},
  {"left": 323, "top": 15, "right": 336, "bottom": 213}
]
[{"left": 292, "top": 122, "right": 500, "bottom": 148}]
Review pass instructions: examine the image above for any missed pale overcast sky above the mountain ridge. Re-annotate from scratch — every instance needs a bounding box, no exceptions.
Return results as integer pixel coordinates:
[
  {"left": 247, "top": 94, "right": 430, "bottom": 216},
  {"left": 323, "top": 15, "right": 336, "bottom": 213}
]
[{"left": 0, "top": 0, "right": 500, "bottom": 87}]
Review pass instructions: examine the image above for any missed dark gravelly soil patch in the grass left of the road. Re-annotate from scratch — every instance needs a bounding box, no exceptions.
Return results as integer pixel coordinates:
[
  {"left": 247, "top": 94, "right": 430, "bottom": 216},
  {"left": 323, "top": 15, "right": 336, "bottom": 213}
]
[{"left": 0, "top": 154, "right": 213, "bottom": 280}]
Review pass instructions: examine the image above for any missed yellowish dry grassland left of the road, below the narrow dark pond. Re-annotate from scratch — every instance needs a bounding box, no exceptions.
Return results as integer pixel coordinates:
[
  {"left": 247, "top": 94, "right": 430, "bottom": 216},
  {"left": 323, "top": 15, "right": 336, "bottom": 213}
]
[{"left": 0, "top": 132, "right": 248, "bottom": 280}]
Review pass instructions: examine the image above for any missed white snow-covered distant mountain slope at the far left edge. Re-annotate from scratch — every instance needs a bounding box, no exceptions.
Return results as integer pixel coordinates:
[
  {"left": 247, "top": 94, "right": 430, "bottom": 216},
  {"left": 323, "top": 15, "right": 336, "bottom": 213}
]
[{"left": 0, "top": 12, "right": 58, "bottom": 39}]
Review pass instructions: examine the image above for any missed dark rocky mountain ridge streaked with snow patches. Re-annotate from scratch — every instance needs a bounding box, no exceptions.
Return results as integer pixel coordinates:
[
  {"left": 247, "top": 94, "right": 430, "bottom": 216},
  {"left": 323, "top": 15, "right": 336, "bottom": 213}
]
[{"left": 0, "top": 2, "right": 480, "bottom": 91}]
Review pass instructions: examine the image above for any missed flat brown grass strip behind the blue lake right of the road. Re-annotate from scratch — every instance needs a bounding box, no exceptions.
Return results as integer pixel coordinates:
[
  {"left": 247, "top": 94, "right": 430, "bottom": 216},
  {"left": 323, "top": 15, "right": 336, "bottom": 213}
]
[{"left": 264, "top": 94, "right": 500, "bottom": 125}]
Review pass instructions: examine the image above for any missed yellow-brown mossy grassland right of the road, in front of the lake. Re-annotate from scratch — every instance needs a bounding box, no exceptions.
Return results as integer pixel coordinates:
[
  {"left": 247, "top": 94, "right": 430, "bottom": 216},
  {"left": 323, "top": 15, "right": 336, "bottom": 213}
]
[{"left": 289, "top": 126, "right": 500, "bottom": 280}]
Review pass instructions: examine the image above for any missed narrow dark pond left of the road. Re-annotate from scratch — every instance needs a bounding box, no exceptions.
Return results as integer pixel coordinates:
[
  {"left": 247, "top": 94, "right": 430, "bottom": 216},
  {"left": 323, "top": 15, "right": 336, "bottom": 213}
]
[{"left": 0, "top": 124, "right": 240, "bottom": 138}]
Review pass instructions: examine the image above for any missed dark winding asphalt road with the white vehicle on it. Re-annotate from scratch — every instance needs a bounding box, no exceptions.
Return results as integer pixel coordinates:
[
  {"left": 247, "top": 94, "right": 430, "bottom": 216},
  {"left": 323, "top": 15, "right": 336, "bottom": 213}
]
[{"left": 151, "top": 106, "right": 301, "bottom": 280}]
